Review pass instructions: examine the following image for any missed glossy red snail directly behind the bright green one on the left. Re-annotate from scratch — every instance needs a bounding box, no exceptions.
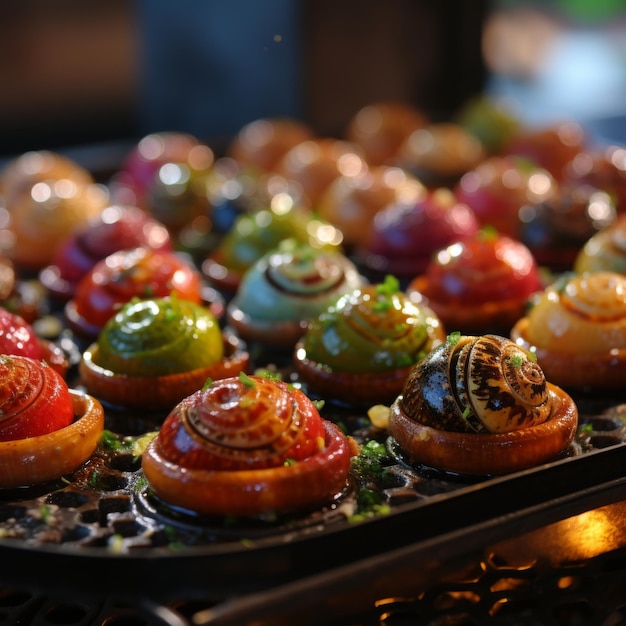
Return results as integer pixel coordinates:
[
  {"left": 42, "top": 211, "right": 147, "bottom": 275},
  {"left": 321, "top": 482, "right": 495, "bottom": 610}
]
[{"left": 64, "top": 246, "right": 222, "bottom": 340}]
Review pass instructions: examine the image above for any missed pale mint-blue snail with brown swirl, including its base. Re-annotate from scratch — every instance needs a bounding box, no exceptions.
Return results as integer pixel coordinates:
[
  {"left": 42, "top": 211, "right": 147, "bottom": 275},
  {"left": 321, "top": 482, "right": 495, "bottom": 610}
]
[{"left": 226, "top": 239, "right": 365, "bottom": 349}]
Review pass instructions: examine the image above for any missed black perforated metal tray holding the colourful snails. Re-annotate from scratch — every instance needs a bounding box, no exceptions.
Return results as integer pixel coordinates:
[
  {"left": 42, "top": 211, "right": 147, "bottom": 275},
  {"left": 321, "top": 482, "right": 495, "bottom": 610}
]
[{"left": 0, "top": 354, "right": 626, "bottom": 603}]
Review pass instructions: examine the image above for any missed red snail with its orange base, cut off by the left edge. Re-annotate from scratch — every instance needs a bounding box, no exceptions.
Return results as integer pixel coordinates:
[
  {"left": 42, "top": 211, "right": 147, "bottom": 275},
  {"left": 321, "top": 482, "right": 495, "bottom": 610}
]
[{"left": 0, "top": 354, "right": 104, "bottom": 489}]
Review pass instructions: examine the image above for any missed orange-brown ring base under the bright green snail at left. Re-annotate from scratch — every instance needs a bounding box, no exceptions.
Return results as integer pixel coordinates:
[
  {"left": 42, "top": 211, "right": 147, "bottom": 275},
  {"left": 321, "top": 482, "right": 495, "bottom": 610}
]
[{"left": 79, "top": 340, "right": 250, "bottom": 411}]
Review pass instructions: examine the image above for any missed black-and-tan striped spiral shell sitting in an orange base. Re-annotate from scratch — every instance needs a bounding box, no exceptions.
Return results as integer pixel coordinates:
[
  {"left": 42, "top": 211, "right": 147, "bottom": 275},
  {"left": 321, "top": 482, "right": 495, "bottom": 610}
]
[{"left": 400, "top": 335, "right": 551, "bottom": 433}]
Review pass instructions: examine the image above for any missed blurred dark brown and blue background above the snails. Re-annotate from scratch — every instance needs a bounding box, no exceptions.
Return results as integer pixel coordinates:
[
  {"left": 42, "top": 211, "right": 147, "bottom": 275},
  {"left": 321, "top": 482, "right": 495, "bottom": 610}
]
[{"left": 0, "top": 0, "right": 626, "bottom": 157}]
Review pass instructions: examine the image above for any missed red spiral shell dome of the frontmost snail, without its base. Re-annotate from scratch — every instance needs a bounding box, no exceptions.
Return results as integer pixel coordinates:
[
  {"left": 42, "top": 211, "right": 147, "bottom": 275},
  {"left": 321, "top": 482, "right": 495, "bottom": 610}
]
[{"left": 155, "top": 376, "right": 324, "bottom": 471}]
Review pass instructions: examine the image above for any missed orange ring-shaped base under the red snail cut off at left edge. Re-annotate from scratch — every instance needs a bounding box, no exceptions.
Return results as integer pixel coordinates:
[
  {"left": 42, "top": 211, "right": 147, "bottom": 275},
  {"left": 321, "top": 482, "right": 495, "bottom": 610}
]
[{"left": 0, "top": 389, "right": 104, "bottom": 489}]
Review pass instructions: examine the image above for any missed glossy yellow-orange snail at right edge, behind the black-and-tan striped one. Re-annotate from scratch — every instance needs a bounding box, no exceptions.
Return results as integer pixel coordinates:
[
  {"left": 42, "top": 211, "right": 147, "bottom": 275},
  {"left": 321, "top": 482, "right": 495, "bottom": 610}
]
[{"left": 511, "top": 271, "right": 626, "bottom": 390}]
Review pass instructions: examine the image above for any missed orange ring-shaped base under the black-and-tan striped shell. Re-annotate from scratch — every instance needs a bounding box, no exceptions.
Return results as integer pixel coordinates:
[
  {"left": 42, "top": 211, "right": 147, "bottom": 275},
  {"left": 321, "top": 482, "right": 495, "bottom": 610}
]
[{"left": 389, "top": 383, "right": 578, "bottom": 475}]
